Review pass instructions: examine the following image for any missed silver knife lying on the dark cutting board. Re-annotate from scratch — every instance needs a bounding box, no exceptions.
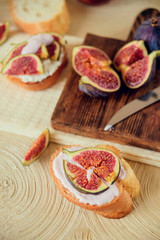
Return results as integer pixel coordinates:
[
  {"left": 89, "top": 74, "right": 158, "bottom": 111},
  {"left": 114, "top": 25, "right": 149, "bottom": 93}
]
[{"left": 104, "top": 86, "right": 160, "bottom": 131}]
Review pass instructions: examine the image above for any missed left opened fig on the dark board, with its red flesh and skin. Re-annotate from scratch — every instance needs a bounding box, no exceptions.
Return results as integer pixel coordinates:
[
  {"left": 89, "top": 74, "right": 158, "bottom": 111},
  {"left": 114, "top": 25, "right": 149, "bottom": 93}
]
[{"left": 72, "top": 45, "right": 121, "bottom": 97}]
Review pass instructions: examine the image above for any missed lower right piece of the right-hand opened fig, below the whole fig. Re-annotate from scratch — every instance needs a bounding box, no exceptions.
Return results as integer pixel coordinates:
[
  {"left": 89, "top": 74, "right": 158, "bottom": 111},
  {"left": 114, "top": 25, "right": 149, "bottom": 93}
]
[{"left": 122, "top": 51, "right": 160, "bottom": 89}]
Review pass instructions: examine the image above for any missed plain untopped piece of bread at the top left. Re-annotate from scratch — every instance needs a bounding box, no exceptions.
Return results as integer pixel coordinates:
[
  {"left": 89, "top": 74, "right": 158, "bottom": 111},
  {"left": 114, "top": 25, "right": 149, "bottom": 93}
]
[{"left": 10, "top": 0, "right": 70, "bottom": 34}]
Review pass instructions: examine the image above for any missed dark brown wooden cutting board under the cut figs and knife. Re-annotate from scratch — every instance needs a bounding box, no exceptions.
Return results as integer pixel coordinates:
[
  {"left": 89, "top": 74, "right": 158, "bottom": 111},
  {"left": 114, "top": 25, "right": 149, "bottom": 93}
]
[{"left": 51, "top": 9, "right": 160, "bottom": 151}]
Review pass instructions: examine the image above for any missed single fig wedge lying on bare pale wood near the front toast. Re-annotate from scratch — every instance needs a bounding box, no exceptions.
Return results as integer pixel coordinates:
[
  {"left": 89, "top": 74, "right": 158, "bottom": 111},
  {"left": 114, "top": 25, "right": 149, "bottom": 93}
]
[{"left": 22, "top": 128, "right": 50, "bottom": 166}]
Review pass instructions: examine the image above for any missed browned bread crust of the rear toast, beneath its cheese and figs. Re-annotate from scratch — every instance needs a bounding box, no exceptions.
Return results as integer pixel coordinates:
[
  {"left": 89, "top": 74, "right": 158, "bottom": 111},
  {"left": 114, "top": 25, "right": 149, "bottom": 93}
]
[{"left": 7, "top": 47, "right": 68, "bottom": 91}]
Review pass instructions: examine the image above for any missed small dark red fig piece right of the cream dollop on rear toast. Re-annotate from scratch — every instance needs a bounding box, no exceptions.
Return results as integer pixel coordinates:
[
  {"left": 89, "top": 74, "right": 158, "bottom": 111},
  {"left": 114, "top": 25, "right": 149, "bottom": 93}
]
[{"left": 46, "top": 41, "right": 61, "bottom": 61}]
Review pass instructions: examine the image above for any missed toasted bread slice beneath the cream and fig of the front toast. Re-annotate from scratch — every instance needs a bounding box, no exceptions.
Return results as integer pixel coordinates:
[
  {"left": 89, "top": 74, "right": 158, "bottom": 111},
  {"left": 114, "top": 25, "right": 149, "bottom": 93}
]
[{"left": 50, "top": 145, "right": 141, "bottom": 219}]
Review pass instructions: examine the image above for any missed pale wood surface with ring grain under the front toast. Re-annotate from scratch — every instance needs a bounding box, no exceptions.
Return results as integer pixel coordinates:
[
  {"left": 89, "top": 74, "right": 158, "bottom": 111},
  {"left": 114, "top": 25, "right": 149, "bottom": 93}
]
[{"left": 0, "top": 133, "right": 160, "bottom": 240}]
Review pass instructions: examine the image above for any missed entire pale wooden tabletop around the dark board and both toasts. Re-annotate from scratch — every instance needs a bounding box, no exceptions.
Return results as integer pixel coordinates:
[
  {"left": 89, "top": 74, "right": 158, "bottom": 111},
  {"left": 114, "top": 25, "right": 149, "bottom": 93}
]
[{"left": 0, "top": 0, "right": 160, "bottom": 240}]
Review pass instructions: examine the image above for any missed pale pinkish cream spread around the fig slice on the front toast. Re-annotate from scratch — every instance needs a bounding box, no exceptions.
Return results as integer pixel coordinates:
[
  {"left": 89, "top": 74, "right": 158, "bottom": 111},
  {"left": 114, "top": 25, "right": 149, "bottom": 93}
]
[{"left": 52, "top": 147, "right": 125, "bottom": 206}]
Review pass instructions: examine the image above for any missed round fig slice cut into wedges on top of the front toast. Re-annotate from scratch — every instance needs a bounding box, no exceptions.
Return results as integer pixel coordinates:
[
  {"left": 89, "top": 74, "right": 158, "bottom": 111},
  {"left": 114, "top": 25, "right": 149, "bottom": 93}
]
[{"left": 63, "top": 147, "right": 120, "bottom": 194}]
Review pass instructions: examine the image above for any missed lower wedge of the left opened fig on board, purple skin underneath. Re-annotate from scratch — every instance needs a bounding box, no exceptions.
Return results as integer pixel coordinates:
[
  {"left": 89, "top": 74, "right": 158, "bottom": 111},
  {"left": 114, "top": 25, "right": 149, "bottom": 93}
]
[{"left": 79, "top": 67, "right": 121, "bottom": 97}]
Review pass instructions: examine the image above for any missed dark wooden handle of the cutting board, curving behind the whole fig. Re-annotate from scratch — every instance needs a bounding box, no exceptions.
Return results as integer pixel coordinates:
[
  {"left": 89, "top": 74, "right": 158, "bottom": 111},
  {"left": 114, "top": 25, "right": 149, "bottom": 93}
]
[{"left": 127, "top": 8, "right": 160, "bottom": 42}]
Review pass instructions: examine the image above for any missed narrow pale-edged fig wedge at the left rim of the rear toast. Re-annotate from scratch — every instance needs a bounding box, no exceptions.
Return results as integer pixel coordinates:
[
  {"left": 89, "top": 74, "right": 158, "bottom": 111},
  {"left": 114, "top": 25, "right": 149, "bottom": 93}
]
[{"left": 1, "top": 42, "right": 27, "bottom": 64}]
